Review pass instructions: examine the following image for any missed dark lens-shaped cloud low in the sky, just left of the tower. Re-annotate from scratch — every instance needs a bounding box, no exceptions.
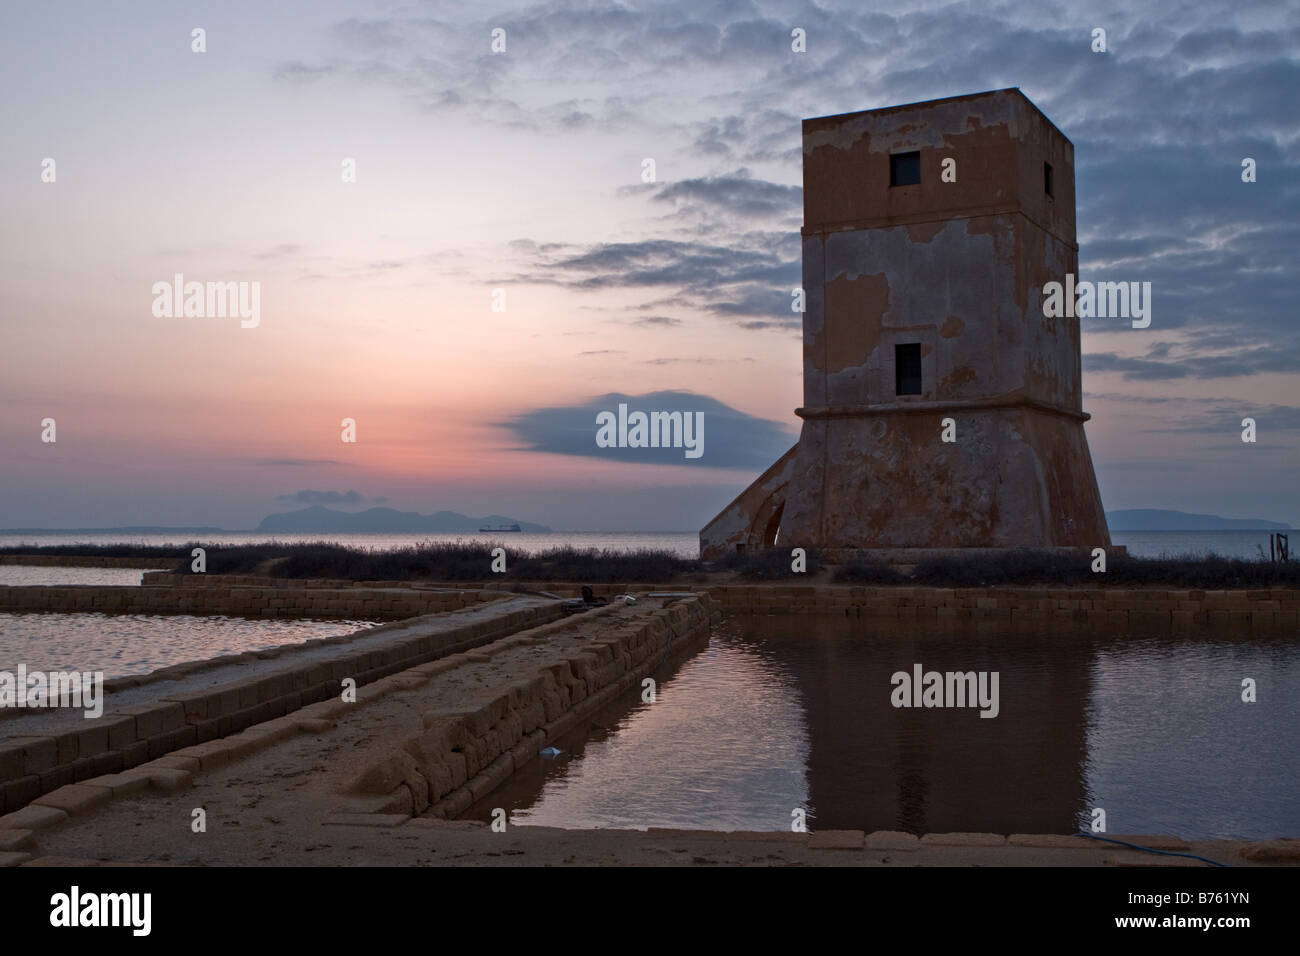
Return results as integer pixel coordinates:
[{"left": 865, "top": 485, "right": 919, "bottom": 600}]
[{"left": 499, "top": 392, "right": 797, "bottom": 470}]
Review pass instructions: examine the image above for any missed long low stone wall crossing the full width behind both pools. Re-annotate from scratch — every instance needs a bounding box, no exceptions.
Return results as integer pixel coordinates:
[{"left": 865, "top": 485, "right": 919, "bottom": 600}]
[{"left": 0, "top": 572, "right": 1300, "bottom": 633}]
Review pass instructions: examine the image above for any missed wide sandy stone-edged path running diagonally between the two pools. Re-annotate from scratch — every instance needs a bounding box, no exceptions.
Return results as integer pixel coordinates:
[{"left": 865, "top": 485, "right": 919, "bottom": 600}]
[{"left": 0, "top": 597, "right": 715, "bottom": 862}]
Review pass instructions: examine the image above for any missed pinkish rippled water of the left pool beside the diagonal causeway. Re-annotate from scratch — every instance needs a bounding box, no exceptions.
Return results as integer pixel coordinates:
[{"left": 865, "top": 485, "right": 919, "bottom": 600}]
[{"left": 0, "top": 613, "right": 374, "bottom": 678}]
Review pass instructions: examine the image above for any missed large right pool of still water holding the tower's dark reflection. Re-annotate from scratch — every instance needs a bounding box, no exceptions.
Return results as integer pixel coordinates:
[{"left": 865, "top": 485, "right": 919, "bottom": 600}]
[{"left": 467, "top": 618, "right": 1300, "bottom": 838}]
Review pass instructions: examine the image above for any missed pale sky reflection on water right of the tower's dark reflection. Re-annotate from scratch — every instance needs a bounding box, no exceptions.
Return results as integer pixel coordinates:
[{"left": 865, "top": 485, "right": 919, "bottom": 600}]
[{"left": 1087, "top": 641, "right": 1300, "bottom": 838}]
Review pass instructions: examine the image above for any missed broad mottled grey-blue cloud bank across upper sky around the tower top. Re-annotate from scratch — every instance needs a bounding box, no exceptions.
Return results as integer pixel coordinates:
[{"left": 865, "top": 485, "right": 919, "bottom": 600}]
[{"left": 271, "top": 0, "right": 1300, "bottom": 364}]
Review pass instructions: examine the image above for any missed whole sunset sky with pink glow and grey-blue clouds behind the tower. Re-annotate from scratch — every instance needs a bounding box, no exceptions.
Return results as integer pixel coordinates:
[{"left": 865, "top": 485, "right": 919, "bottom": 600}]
[{"left": 0, "top": 0, "right": 1300, "bottom": 531}]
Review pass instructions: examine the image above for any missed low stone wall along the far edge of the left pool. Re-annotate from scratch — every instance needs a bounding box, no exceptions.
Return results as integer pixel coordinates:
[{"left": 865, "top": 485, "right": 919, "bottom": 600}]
[{"left": 0, "top": 575, "right": 502, "bottom": 620}]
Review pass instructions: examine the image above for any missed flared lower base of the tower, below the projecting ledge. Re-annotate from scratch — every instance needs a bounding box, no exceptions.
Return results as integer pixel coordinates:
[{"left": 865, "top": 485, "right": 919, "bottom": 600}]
[{"left": 781, "top": 407, "right": 1110, "bottom": 549}]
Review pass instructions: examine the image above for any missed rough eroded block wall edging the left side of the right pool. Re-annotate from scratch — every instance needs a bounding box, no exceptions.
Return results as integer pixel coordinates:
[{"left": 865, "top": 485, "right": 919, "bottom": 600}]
[{"left": 346, "top": 594, "right": 719, "bottom": 817}]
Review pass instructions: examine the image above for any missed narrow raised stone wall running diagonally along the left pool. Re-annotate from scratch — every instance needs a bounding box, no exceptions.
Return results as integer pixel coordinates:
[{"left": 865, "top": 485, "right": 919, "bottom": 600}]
[{"left": 0, "top": 602, "right": 563, "bottom": 813}]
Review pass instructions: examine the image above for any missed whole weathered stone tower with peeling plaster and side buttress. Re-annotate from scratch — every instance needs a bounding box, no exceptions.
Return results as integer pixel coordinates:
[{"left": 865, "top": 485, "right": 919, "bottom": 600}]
[{"left": 701, "top": 88, "right": 1110, "bottom": 559}]
